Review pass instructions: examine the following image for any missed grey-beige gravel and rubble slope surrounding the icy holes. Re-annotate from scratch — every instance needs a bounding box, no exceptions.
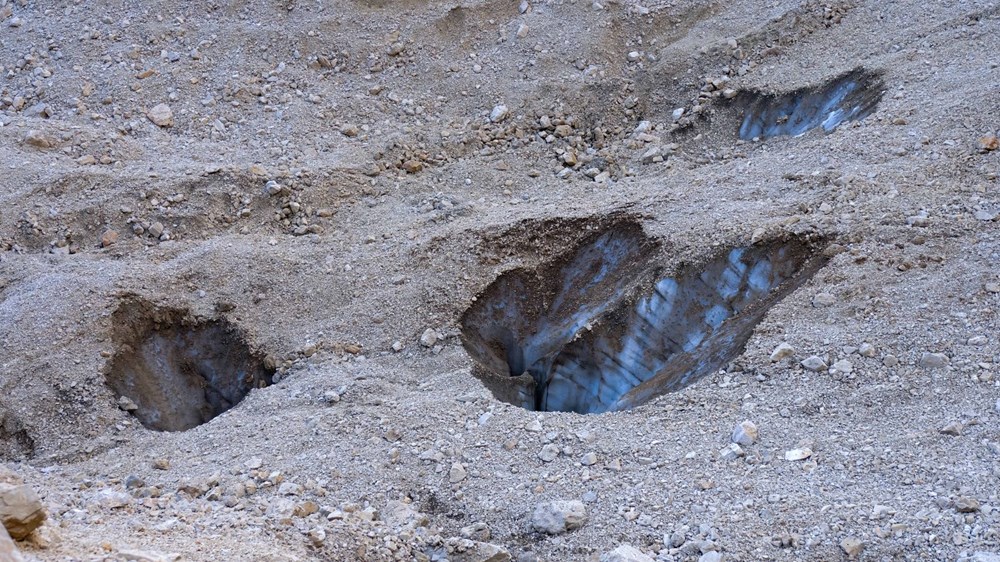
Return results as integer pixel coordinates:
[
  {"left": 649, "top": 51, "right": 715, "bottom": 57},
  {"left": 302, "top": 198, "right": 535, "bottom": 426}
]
[{"left": 0, "top": 0, "right": 1000, "bottom": 561}]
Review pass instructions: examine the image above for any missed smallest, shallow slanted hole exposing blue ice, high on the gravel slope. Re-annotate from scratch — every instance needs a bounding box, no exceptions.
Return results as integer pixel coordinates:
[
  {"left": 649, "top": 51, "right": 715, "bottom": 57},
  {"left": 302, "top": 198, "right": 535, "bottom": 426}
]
[{"left": 738, "top": 68, "right": 884, "bottom": 140}]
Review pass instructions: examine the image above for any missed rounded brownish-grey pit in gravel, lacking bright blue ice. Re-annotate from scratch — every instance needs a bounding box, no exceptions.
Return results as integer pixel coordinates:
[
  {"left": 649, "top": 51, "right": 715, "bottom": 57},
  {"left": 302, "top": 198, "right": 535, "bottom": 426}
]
[{"left": 106, "top": 302, "right": 274, "bottom": 431}]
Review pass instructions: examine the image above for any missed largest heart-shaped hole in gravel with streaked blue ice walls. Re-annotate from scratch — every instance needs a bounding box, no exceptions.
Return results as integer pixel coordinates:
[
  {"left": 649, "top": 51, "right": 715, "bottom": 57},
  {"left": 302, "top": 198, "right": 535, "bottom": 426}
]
[{"left": 462, "top": 223, "right": 823, "bottom": 413}]
